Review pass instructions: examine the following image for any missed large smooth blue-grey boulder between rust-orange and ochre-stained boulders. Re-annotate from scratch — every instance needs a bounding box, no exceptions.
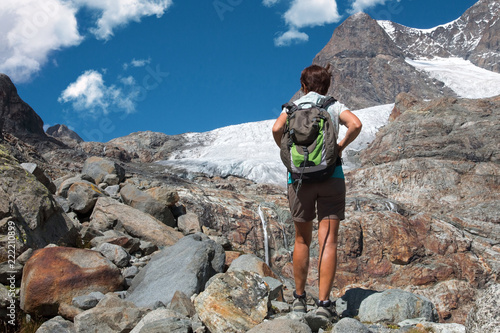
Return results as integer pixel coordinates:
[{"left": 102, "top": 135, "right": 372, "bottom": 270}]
[{"left": 127, "top": 233, "right": 225, "bottom": 307}]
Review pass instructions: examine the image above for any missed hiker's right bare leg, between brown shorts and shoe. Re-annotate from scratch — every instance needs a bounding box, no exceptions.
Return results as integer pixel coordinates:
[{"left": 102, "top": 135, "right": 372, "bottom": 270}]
[{"left": 318, "top": 220, "right": 340, "bottom": 301}]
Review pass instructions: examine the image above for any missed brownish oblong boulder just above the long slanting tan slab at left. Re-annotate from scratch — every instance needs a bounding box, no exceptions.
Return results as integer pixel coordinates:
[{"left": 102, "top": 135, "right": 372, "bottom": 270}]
[{"left": 120, "top": 184, "right": 176, "bottom": 227}]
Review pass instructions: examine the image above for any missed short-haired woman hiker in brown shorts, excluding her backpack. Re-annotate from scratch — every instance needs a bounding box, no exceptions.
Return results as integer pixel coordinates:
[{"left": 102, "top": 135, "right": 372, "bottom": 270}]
[{"left": 272, "top": 65, "right": 362, "bottom": 319}]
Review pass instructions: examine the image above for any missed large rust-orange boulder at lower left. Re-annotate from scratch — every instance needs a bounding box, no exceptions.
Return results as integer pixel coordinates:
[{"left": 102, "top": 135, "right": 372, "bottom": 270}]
[{"left": 20, "top": 247, "right": 123, "bottom": 316}]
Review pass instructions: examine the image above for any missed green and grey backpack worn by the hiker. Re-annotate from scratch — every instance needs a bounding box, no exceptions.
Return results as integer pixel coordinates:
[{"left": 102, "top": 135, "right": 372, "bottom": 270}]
[{"left": 280, "top": 97, "right": 338, "bottom": 182}]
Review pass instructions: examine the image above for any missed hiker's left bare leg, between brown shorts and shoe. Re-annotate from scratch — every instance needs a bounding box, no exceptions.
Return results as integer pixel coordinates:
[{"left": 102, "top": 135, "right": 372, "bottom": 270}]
[{"left": 293, "top": 222, "right": 312, "bottom": 295}]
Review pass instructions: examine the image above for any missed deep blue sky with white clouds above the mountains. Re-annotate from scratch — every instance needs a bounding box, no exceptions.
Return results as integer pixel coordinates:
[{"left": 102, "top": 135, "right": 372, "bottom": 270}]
[{"left": 0, "top": 0, "right": 476, "bottom": 142}]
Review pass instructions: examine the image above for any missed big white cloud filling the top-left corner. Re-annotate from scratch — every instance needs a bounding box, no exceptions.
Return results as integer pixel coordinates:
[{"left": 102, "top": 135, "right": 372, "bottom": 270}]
[{"left": 0, "top": 0, "right": 83, "bottom": 82}]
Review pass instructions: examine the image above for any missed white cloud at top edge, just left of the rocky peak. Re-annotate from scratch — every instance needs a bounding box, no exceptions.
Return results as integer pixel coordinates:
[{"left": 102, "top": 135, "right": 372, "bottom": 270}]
[{"left": 274, "top": 0, "right": 341, "bottom": 46}]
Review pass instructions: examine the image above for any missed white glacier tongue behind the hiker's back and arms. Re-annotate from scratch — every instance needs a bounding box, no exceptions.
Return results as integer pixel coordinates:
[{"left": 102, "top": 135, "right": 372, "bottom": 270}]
[{"left": 157, "top": 104, "right": 394, "bottom": 186}]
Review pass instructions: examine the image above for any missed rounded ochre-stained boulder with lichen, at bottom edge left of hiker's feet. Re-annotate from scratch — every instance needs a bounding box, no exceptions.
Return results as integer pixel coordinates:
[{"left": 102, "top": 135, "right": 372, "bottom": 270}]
[{"left": 194, "top": 271, "right": 269, "bottom": 333}]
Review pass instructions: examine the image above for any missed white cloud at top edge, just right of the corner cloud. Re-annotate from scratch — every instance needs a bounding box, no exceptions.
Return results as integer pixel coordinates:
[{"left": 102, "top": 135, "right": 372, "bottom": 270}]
[{"left": 71, "top": 0, "right": 172, "bottom": 40}]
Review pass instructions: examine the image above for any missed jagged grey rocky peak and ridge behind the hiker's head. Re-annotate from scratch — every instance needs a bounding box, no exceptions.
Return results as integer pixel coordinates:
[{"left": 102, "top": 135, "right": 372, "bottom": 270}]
[{"left": 310, "top": 0, "right": 500, "bottom": 110}]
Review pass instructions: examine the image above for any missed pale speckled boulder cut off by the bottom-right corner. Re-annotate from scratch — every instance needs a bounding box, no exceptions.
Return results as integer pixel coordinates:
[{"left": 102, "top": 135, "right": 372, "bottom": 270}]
[{"left": 465, "top": 283, "right": 500, "bottom": 333}]
